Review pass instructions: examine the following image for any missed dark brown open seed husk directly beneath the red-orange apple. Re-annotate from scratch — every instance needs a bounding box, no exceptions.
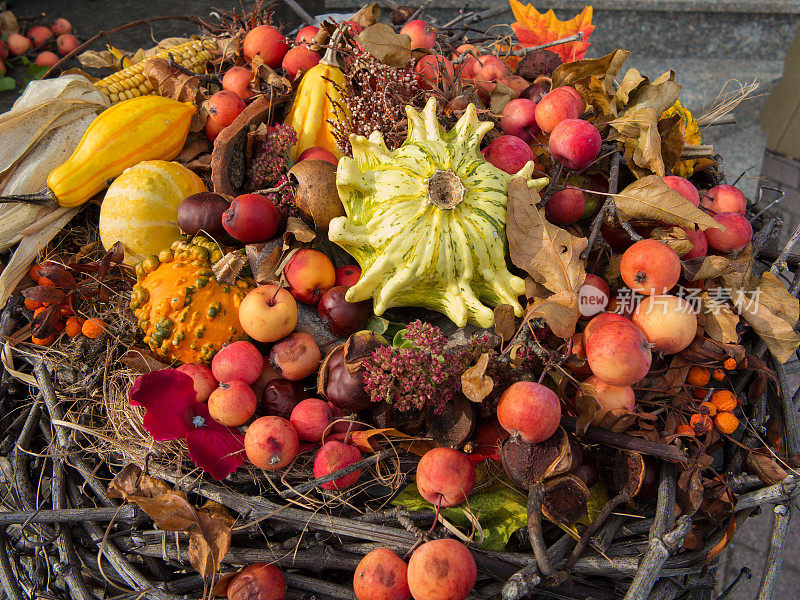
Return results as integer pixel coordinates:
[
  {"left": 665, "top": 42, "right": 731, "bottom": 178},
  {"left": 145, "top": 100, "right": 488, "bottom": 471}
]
[{"left": 500, "top": 427, "right": 580, "bottom": 489}]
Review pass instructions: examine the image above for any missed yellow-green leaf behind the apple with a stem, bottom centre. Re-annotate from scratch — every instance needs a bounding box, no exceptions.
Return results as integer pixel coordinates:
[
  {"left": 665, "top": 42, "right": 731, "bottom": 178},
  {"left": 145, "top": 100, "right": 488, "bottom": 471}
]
[{"left": 393, "top": 463, "right": 528, "bottom": 550}]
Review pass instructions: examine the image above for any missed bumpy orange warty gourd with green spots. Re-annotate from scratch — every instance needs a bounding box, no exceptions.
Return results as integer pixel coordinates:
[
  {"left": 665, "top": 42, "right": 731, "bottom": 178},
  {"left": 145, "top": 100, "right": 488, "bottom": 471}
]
[{"left": 130, "top": 236, "right": 254, "bottom": 363}]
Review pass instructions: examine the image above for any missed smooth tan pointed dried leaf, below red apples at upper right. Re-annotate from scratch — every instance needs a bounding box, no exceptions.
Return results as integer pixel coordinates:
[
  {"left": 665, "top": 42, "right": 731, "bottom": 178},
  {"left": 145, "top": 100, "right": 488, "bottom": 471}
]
[{"left": 614, "top": 175, "right": 724, "bottom": 230}]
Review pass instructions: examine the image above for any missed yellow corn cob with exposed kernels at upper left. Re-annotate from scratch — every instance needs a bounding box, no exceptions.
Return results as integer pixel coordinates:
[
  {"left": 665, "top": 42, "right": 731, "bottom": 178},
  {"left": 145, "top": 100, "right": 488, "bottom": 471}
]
[{"left": 95, "top": 38, "right": 217, "bottom": 104}]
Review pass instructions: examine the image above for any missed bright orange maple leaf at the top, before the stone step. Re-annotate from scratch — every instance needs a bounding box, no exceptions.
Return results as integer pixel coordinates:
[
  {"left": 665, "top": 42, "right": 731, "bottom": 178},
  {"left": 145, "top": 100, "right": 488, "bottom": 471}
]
[{"left": 508, "top": 0, "right": 594, "bottom": 62}]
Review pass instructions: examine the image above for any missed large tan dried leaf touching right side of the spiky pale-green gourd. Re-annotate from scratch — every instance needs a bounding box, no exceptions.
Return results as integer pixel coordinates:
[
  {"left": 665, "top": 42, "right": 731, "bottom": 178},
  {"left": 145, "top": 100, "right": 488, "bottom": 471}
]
[{"left": 506, "top": 177, "right": 584, "bottom": 294}]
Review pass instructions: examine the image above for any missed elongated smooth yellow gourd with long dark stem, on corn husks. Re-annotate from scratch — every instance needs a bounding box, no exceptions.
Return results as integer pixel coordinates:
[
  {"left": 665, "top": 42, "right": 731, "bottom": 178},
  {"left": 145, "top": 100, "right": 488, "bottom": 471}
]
[{"left": 0, "top": 96, "right": 197, "bottom": 207}]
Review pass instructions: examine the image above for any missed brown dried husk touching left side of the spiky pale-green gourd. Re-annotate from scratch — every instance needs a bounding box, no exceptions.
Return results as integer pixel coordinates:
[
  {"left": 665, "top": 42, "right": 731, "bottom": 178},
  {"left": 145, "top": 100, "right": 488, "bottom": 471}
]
[{"left": 289, "top": 158, "right": 344, "bottom": 231}]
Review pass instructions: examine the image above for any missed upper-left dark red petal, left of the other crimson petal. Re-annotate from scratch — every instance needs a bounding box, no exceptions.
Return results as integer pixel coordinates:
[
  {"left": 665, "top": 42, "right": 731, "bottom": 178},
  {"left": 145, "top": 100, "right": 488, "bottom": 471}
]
[{"left": 128, "top": 369, "right": 196, "bottom": 441}]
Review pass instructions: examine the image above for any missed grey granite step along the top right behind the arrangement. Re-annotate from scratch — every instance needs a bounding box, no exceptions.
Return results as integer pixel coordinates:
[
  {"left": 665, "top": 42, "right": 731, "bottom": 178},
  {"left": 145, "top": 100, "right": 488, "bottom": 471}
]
[{"left": 325, "top": 0, "right": 800, "bottom": 61}]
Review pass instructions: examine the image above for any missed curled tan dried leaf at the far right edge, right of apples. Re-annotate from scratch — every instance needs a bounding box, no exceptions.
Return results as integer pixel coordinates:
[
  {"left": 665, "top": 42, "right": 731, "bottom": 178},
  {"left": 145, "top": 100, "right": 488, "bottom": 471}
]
[{"left": 724, "top": 271, "right": 800, "bottom": 363}]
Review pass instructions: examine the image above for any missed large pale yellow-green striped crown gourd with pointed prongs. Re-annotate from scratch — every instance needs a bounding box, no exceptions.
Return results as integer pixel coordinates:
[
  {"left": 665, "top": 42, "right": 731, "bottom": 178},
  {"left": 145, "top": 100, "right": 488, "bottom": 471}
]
[{"left": 328, "top": 98, "right": 546, "bottom": 327}]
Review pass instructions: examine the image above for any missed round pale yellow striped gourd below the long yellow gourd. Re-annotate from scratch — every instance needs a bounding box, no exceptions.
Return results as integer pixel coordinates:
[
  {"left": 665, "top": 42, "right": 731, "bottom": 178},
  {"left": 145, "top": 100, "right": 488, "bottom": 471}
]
[{"left": 100, "top": 160, "right": 208, "bottom": 265}]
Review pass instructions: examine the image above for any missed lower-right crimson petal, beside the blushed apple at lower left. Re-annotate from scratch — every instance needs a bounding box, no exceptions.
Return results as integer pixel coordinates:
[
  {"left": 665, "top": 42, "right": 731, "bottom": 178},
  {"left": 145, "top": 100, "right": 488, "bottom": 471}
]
[{"left": 186, "top": 403, "right": 244, "bottom": 481}]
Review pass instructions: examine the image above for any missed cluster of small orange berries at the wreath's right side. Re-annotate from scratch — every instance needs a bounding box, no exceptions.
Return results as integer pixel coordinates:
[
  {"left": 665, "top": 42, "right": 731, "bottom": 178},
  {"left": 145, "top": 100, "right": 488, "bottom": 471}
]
[{"left": 677, "top": 366, "right": 739, "bottom": 435}]
